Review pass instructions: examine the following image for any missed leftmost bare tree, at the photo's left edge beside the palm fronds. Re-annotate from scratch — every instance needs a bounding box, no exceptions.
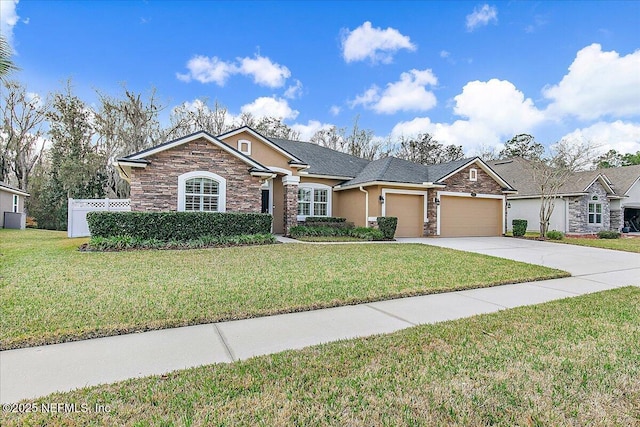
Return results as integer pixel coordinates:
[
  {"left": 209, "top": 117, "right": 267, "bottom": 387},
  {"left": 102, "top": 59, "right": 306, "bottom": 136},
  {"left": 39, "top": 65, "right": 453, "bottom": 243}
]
[{"left": 0, "top": 81, "right": 48, "bottom": 191}]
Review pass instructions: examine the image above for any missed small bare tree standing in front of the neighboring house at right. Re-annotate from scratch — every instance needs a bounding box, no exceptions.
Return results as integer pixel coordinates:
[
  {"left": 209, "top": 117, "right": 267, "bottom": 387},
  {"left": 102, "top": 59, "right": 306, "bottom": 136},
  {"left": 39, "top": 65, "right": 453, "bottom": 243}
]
[{"left": 529, "top": 139, "right": 596, "bottom": 239}]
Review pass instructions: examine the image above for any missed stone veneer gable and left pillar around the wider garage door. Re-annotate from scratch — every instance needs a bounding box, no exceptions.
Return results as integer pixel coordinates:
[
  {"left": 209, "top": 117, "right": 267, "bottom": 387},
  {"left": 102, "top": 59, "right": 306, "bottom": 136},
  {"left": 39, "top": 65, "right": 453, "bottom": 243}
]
[{"left": 424, "top": 165, "right": 503, "bottom": 236}]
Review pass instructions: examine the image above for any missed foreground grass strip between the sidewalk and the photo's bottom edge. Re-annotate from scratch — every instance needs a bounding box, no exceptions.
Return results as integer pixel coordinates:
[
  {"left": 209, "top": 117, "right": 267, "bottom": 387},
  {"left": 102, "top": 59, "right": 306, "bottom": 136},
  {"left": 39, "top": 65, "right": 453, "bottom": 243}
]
[{"left": 3, "top": 287, "right": 640, "bottom": 426}]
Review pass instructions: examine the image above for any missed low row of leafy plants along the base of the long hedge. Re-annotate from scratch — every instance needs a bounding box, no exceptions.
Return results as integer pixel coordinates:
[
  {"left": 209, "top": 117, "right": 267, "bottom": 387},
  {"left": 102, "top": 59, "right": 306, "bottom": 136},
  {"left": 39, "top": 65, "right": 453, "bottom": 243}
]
[{"left": 88, "top": 234, "right": 276, "bottom": 251}]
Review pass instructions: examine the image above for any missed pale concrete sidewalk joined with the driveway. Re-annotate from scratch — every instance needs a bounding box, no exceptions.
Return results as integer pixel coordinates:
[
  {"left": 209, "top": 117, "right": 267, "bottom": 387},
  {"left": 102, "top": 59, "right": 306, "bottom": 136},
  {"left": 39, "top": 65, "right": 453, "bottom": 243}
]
[{"left": 0, "top": 238, "right": 640, "bottom": 403}]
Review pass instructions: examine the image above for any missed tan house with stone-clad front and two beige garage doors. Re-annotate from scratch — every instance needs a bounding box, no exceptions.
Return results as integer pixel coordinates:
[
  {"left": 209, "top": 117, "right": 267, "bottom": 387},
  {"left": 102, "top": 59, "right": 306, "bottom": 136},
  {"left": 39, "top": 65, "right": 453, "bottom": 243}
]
[{"left": 115, "top": 126, "right": 515, "bottom": 241}]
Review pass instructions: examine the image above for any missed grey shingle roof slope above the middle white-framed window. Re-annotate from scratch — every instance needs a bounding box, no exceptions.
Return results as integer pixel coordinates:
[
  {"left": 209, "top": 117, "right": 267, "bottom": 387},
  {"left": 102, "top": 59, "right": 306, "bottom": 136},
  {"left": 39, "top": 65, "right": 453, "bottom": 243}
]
[{"left": 269, "top": 138, "right": 369, "bottom": 177}]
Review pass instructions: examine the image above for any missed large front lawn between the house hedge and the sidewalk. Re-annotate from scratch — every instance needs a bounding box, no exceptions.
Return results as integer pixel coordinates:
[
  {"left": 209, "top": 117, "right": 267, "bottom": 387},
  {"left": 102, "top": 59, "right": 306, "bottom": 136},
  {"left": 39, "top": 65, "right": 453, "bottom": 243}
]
[{"left": 0, "top": 230, "right": 568, "bottom": 349}]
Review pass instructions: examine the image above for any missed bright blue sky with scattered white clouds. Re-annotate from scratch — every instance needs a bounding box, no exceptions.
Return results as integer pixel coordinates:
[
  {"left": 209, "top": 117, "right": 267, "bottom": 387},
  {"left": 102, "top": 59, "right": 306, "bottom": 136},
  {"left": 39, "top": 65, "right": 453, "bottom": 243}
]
[{"left": 0, "top": 0, "right": 640, "bottom": 154}]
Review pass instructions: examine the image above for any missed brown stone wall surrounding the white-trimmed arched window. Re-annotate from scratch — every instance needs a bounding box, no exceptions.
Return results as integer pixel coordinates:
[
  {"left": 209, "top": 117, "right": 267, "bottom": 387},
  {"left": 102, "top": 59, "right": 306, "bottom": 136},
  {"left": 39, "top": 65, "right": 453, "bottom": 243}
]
[{"left": 131, "top": 138, "right": 262, "bottom": 212}]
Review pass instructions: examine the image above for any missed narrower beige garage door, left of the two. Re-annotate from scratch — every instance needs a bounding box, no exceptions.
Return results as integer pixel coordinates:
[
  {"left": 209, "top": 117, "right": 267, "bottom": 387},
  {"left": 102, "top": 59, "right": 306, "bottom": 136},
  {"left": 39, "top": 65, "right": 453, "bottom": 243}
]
[{"left": 384, "top": 193, "right": 424, "bottom": 237}]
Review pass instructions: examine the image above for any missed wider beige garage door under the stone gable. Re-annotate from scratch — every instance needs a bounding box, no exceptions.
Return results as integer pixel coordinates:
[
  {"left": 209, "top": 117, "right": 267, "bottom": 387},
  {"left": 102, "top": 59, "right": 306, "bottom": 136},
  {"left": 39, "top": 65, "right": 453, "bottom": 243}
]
[{"left": 440, "top": 196, "right": 502, "bottom": 237}]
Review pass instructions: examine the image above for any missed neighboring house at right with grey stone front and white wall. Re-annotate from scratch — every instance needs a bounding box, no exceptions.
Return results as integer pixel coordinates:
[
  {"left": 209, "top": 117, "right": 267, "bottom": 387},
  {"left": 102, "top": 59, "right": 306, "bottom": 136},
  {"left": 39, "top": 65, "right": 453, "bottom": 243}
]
[{"left": 489, "top": 158, "right": 640, "bottom": 234}]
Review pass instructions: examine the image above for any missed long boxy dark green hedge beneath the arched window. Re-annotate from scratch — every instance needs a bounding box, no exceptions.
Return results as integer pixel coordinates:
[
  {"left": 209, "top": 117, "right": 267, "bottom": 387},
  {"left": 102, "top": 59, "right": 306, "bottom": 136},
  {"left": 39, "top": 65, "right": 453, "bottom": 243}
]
[{"left": 87, "top": 212, "right": 272, "bottom": 242}]
